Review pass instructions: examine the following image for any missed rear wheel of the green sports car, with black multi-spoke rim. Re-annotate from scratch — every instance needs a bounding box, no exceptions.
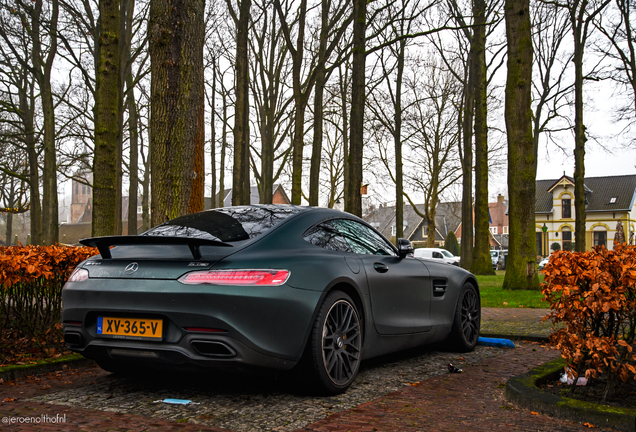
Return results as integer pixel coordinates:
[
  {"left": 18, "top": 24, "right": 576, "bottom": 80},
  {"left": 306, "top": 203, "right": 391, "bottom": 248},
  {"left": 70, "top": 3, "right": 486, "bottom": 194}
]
[{"left": 307, "top": 291, "right": 362, "bottom": 395}]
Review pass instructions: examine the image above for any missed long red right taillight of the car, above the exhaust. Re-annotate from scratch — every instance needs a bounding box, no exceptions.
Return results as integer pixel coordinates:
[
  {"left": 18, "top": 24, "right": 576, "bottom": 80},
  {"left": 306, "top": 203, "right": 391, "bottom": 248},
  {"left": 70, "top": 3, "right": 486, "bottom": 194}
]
[{"left": 179, "top": 270, "right": 290, "bottom": 286}]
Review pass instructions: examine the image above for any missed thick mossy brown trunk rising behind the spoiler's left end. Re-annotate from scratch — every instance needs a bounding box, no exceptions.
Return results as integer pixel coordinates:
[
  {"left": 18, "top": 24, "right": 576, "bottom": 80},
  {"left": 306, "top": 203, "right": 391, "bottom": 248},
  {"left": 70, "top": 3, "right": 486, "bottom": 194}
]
[{"left": 92, "top": 0, "right": 121, "bottom": 236}]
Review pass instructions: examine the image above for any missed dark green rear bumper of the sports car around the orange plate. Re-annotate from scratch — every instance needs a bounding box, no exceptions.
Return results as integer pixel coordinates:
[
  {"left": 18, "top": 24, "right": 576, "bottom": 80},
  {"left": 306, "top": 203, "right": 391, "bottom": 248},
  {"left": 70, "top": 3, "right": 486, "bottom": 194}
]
[{"left": 62, "top": 279, "right": 322, "bottom": 370}]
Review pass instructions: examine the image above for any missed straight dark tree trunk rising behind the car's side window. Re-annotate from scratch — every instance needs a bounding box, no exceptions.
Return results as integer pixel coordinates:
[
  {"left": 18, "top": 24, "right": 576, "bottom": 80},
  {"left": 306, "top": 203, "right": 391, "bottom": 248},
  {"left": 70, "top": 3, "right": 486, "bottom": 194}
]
[{"left": 345, "top": 0, "right": 367, "bottom": 217}]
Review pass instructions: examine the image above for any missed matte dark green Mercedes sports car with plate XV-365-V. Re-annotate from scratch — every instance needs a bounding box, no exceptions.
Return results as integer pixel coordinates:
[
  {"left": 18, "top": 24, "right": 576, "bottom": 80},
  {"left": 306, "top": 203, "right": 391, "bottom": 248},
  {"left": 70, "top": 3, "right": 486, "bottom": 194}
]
[{"left": 62, "top": 205, "right": 481, "bottom": 394}]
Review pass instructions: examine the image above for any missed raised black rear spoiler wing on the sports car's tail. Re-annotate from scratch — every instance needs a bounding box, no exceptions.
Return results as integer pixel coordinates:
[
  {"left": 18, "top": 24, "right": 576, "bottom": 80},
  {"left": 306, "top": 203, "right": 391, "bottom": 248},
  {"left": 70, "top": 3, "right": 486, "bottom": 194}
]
[{"left": 80, "top": 236, "right": 232, "bottom": 260}]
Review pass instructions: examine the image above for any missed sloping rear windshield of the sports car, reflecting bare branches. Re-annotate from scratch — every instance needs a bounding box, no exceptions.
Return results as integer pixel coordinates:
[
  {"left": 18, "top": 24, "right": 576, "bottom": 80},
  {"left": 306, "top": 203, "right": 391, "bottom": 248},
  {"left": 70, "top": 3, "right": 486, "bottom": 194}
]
[{"left": 141, "top": 206, "right": 301, "bottom": 242}]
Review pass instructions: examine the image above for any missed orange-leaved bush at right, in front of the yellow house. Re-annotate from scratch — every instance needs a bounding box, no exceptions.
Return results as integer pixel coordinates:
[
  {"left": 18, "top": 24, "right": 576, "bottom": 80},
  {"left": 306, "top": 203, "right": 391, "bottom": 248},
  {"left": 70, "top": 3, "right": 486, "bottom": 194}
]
[{"left": 542, "top": 244, "right": 636, "bottom": 395}]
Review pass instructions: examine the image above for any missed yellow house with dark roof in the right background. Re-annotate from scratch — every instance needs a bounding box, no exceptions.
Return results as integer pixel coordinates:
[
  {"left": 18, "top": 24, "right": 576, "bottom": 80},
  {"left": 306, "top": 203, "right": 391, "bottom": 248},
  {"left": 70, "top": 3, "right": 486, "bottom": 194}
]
[{"left": 535, "top": 175, "right": 636, "bottom": 256}]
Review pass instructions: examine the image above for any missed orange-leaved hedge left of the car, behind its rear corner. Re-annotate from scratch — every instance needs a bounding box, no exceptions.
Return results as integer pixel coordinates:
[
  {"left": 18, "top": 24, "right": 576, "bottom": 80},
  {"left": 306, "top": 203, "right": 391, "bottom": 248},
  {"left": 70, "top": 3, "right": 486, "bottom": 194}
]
[{"left": 0, "top": 245, "right": 98, "bottom": 349}]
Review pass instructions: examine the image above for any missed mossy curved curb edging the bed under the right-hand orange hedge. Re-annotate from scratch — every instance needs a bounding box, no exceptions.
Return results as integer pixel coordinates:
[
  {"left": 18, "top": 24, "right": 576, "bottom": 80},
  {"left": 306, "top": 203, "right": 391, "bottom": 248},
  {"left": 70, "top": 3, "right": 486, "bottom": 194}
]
[{"left": 505, "top": 358, "right": 636, "bottom": 432}]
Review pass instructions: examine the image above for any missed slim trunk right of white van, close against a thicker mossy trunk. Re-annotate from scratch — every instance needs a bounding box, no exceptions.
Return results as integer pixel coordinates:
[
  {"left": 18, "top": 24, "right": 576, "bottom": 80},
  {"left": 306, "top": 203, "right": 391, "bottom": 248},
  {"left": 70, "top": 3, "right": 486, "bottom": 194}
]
[{"left": 460, "top": 54, "right": 475, "bottom": 270}]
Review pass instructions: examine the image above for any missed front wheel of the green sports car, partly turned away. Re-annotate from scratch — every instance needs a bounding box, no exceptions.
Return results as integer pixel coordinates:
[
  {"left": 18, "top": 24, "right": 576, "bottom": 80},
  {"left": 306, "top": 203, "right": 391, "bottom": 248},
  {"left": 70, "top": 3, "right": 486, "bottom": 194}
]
[{"left": 447, "top": 282, "right": 481, "bottom": 352}]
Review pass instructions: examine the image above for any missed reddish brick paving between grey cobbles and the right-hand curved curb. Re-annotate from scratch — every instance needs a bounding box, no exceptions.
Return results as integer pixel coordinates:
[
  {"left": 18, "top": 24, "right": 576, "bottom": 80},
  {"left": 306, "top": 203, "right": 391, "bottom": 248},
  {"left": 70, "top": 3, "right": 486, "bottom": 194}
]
[{"left": 298, "top": 343, "right": 608, "bottom": 432}]
